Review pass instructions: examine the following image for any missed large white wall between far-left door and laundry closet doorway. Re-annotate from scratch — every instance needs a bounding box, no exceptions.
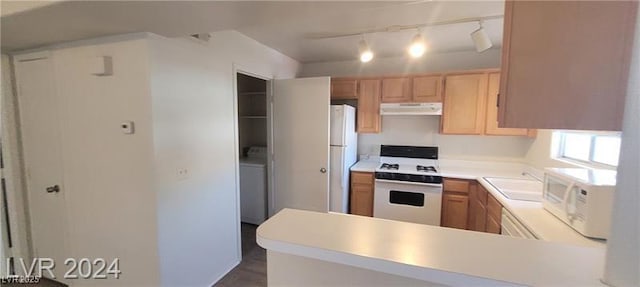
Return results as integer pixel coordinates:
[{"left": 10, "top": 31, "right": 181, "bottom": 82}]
[{"left": 9, "top": 31, "right": 299, "bottom": 286}]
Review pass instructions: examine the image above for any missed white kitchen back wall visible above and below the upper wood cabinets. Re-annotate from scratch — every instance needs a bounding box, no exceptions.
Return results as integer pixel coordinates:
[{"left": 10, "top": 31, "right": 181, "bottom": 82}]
[{"left": 301, "top": 48, "right": 533, "bottom": 160}]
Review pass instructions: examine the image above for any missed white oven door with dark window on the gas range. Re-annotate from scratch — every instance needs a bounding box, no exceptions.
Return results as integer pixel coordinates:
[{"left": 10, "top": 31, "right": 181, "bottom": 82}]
[{"left": 373, "top": 179, "right": 442, "bottom": 225}]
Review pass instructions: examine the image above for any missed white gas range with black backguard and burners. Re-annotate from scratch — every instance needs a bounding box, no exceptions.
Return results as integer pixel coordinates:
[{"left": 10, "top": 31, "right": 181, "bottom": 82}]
[{"left": 373, "top": 145, "right": 442, "bottom": 225}]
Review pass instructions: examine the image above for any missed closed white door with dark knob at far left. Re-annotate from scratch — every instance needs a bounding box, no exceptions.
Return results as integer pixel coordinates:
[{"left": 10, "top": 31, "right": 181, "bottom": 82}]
[{"left": 15, "top": 53, "right": 69, "bottom": 280}]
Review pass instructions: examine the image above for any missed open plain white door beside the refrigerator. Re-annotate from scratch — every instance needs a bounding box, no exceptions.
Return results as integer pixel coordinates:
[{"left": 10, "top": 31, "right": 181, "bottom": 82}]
[{"left": 272, "top": 77, "right": 330, "bottom": 212}]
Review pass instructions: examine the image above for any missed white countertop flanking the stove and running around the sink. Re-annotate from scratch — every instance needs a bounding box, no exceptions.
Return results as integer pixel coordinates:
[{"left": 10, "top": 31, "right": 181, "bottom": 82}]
[{"left": 351, "top": 160, "right": 606, "bottom": 249}]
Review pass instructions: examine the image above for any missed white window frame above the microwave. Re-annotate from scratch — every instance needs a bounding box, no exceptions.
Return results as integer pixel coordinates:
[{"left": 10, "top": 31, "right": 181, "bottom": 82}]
[{"left": 552, "top": 130, "right": 621, "bottom": 170}]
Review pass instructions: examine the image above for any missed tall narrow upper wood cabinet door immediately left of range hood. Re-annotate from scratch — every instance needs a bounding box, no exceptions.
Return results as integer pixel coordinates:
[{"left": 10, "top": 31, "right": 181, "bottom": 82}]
[{"left": 357, "top": 80, "right": 380, "bottom": 133}]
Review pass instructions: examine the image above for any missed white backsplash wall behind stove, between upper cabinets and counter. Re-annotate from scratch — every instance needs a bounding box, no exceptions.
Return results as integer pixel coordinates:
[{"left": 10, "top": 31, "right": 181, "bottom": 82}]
[{"left": 358, "top": 116, "right": 533, "bottom": 161}]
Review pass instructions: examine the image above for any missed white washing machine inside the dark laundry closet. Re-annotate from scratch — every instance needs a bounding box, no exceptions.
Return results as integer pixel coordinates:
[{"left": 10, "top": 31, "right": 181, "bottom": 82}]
[{"left": 240, "top": 147, "right": 267, "bottom": 225}]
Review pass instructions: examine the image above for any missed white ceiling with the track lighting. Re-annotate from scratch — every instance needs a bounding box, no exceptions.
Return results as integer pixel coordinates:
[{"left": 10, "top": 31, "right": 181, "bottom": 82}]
[{"left": 0, "top": 0, "right": 504, "bottom": 63}]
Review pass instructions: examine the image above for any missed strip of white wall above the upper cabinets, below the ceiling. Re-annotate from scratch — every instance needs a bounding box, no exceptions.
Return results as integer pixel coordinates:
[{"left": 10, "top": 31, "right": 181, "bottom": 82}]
[{"left": 300, "top": 48, "right": 501, "bottom": 77}]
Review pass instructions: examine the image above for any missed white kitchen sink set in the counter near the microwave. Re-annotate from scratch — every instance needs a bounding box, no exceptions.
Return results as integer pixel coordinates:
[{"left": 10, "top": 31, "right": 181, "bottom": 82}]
[{"left": 484, "top": 177, "right": 542, "bottom": 202}]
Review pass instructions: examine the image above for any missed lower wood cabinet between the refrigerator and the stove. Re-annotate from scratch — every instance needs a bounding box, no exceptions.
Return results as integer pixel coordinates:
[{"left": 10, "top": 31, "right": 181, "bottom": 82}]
[{"left": 349, "top": 171, "right": 374, "bottom": 217}]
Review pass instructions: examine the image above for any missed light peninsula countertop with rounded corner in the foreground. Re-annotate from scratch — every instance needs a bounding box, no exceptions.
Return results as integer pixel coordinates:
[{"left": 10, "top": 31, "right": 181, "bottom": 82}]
[{"left": 256, "top": 209, "right": 605, "bottom": 286}]
